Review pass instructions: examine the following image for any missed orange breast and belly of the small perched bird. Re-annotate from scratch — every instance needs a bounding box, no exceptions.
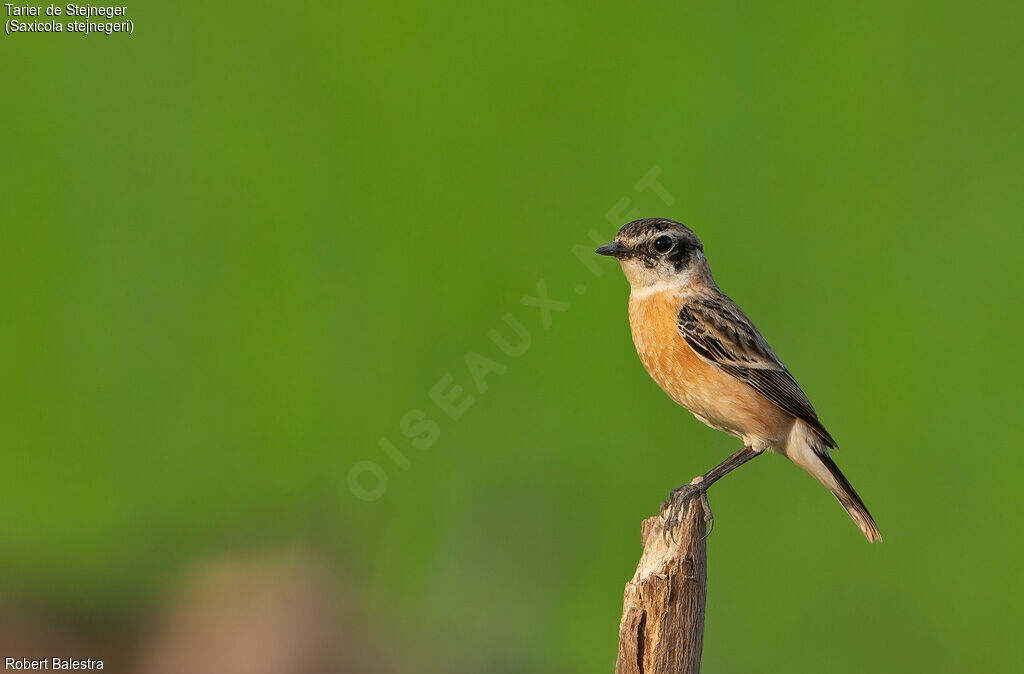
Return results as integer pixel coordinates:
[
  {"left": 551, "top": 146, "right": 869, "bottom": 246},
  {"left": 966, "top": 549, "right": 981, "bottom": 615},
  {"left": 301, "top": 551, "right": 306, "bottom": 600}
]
[{"left": 630, "top": 291, "right": 794, "bottom": 449}]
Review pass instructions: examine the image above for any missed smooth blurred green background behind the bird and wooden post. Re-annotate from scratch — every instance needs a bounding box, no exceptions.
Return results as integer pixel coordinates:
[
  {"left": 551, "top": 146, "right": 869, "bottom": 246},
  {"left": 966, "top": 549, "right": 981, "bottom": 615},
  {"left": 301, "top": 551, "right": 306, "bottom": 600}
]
[{"left": 0, "top": 2, "right": 1024, "bottom": 673}]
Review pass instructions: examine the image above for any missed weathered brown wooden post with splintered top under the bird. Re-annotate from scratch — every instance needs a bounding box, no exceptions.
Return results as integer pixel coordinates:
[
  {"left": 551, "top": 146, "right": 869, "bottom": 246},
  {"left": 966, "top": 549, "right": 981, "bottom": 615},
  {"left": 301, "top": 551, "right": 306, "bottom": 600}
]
[{"left": 615, "top": 498, "right": 708, "bottom": 674}]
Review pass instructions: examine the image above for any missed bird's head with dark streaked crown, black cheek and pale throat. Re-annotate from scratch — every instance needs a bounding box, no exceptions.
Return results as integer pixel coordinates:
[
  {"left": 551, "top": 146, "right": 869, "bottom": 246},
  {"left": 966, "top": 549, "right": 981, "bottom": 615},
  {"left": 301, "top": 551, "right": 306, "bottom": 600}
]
[{"left": 597, "top": 217, "right": 711, "bottom": 289}]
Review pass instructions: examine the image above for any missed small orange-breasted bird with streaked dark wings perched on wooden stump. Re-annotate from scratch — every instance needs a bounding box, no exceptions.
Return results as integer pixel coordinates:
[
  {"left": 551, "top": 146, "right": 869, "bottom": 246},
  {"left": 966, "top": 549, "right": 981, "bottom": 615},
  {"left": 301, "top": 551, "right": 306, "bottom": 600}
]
[{"left": 596, "top": 217, "right": 882, "bottom": 543}]
